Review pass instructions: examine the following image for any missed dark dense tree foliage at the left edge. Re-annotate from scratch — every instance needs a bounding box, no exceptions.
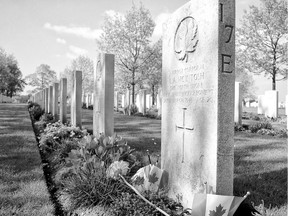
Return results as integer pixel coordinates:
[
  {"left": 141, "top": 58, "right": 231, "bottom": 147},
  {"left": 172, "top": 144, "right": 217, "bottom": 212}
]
[{"left": 0, "top": 48, "right": 25, "bottom": 97}]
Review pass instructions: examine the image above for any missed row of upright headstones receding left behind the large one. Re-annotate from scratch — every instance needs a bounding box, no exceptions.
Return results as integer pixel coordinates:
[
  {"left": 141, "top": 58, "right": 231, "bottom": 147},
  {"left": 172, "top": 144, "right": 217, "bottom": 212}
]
[{"left": 33, "top": 53, "right": 114, "bottom": 136}]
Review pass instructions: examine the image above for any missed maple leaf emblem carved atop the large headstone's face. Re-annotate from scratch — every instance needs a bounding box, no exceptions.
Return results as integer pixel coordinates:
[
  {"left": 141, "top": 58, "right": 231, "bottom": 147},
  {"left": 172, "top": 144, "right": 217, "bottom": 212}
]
[{"left": 174, "top": 16, "right": 199, "bottom": 62}]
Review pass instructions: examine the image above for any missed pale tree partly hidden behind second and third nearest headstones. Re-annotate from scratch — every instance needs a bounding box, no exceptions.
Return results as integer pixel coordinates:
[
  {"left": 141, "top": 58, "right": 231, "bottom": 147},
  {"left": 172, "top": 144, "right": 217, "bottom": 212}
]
[{"left": 61, "top": 55, "right": 94, "bottom": 94}]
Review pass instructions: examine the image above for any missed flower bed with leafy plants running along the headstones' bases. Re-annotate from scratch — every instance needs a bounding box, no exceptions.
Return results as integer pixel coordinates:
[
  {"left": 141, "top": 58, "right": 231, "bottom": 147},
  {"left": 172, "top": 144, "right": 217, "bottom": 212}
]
[{"left": 29, "top": 101, "right": 258, "bottom": 216}]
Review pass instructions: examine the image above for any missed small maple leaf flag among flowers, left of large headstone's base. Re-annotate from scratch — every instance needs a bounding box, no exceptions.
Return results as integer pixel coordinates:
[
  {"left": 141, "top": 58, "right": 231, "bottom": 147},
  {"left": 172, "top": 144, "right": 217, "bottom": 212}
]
[{"left": 131, "top": 164, "right": 168, "bottom": 193}]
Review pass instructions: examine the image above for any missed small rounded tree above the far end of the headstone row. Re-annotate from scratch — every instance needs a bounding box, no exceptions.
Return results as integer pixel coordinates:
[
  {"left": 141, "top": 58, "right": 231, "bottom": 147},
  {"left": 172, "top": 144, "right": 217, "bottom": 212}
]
[{"left": 25, "top": 64, "right": 57, "bottom": 92}]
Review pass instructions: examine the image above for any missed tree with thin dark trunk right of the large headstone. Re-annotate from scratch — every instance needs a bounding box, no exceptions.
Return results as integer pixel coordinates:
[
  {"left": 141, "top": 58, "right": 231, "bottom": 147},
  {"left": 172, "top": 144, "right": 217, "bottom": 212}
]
[{"left": 236, "top": 0, "right": 288, "bottom": 90}]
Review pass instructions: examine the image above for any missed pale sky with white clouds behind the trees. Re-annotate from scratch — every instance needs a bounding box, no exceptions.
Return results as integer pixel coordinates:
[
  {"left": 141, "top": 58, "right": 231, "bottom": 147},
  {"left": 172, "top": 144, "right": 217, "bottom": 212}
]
[{"left": 0, "top": 0, "right": 287, "bottom": 101}]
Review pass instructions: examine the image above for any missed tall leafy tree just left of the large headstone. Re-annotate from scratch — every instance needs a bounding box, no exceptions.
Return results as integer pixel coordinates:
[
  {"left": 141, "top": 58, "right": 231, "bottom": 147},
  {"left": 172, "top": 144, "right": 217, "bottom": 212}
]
[{"left": 97, "top": 4, "right": 155, "bottom": 104}]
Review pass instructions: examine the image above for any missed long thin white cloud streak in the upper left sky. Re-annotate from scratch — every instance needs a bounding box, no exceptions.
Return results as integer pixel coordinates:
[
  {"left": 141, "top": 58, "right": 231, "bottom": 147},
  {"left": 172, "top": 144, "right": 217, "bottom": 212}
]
[{"left": 43, "top": 22, "right": 102, "bottom": 39}]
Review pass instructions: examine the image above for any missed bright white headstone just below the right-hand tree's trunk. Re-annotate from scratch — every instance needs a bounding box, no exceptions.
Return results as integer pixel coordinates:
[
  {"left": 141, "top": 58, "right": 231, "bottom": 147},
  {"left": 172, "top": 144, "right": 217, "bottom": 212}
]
[{"left": 265, "top": 90, "right": 279, "bottom": 118}]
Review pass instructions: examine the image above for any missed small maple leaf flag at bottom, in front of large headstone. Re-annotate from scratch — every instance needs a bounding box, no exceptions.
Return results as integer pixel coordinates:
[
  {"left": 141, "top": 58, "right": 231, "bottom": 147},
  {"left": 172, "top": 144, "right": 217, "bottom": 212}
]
[{"left": 192, "top": 194, "right": 246, "bottom": 216}]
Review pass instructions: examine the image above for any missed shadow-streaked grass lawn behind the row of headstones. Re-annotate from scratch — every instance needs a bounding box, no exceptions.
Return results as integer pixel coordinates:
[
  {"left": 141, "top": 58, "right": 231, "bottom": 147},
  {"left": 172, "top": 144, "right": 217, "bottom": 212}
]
[{"left": 82, "top": 109, "right": 287, "bottom": 216}]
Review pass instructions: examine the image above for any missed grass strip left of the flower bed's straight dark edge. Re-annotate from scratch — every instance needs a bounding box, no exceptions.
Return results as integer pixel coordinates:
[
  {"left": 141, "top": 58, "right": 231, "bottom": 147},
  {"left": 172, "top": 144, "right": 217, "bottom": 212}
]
[{"left": 0, "top": 104, "right": 54, "bottom": 216}]
